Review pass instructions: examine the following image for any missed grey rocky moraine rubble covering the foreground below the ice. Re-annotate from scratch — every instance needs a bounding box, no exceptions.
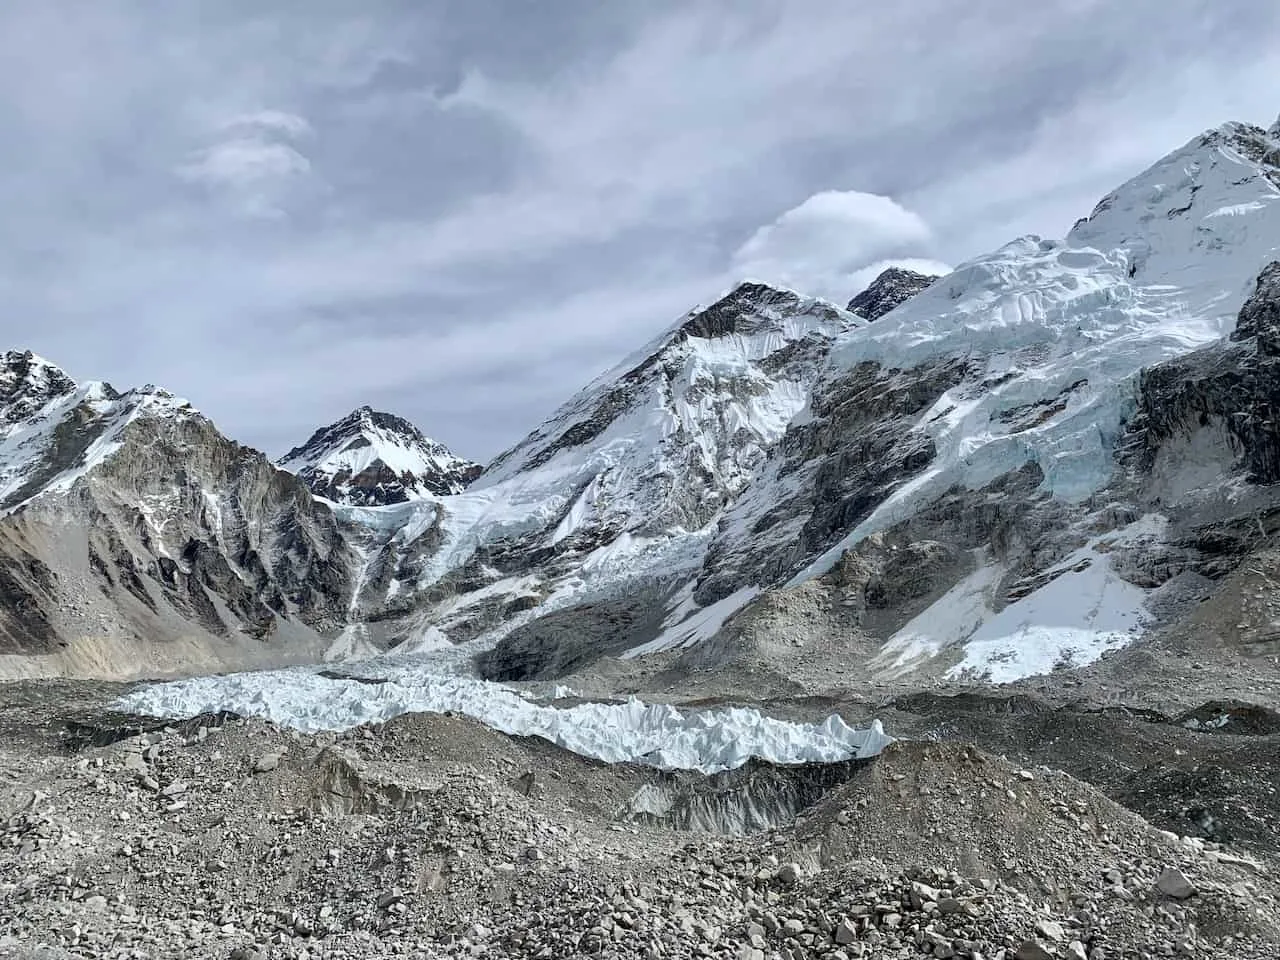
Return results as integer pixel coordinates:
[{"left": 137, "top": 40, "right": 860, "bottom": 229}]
[{"left": 0, "top": 652, "right": 1280, "bottom": 960}]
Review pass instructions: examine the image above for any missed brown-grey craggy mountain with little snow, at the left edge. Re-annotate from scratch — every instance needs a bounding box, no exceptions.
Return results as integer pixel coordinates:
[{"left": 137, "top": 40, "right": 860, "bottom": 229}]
[{"left": 0, "top": 352, "right": 353, "bottom": 676}]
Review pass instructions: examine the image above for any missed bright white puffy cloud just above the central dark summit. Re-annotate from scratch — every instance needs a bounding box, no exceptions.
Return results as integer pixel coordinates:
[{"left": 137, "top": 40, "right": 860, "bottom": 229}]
[{"left": 733, "top": 191, "right": 932, "bottom": 302}]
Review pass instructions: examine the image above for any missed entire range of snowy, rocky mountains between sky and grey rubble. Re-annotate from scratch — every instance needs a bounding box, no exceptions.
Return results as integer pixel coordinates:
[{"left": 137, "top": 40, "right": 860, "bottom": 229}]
[{"left": 0, "top": 114, "right": 1280, "bottom": 690}]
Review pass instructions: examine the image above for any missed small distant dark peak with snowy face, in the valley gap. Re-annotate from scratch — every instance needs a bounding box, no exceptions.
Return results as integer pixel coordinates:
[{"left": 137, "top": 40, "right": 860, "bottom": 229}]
[{"left": 279, "top": 407, "right": 484, "bottom": 507}]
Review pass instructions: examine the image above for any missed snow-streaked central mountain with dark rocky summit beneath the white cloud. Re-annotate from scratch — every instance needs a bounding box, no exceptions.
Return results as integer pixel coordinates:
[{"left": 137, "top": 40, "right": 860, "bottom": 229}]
[{"left": 352, "top": 283, "right": 863, "bottom": 660}]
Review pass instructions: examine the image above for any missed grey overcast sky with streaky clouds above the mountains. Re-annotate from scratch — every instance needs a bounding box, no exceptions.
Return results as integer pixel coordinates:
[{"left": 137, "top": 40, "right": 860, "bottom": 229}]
[{"left": 0, "top": 0, "right": 1280, "bottom": 460}]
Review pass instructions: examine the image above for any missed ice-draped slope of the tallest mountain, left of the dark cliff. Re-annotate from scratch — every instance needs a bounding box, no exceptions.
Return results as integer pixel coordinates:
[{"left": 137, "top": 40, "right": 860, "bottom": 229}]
[{"left": 650, "top": 116, "right": 1280, "bottom": 678}]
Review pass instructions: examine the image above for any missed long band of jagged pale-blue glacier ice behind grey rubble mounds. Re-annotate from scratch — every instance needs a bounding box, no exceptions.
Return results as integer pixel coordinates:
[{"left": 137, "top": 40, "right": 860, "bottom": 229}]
[{"left": 114, "top": 660, "right": 892, "bottom": 773}]
